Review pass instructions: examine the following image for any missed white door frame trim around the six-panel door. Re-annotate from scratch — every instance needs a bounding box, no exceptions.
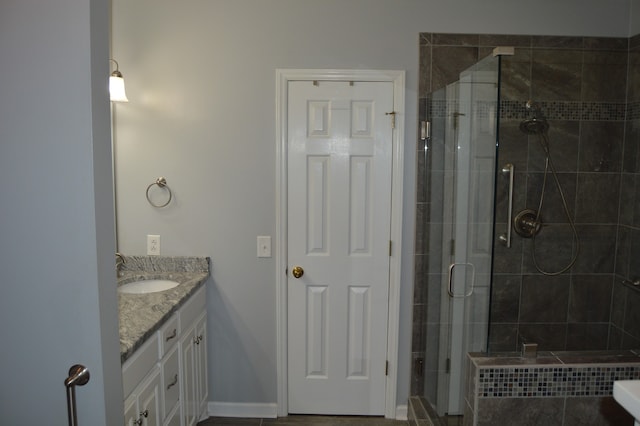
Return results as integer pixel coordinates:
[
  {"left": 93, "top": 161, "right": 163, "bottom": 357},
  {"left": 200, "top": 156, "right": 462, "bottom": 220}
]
[{"left": 275, "top": 69, "right": 405, "bottom": 418}]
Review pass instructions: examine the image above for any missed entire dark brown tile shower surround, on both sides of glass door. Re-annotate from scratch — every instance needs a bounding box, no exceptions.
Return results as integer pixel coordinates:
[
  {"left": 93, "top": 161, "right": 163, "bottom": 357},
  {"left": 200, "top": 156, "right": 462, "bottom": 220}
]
[{"left": 412, "top": 33, "right": 640, "bottom": 396}]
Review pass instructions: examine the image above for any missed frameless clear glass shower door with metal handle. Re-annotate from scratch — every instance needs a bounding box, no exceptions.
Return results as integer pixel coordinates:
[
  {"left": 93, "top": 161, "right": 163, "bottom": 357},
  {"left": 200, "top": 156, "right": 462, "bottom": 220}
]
[{"left": 422, "top": 56, "right": 500, "bottom": 416}]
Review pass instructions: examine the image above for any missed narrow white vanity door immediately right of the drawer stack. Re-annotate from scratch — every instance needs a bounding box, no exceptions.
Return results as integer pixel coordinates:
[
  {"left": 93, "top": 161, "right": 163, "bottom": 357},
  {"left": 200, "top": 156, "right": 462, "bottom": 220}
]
[{"left": 180, "top": 325, "right": 198, "bottom": 426}]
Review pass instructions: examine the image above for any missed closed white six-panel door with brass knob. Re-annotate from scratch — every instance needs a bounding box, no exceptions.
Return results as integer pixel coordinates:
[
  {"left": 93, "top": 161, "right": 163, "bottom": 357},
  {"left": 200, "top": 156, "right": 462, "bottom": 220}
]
[{"left": 287, "top": 81, "right": 393, "bottom": 415}]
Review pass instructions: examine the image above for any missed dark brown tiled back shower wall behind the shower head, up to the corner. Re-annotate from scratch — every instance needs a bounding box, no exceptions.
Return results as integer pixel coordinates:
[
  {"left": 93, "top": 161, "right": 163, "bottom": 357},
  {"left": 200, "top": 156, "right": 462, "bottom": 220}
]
[{"left": 490, "top": 37, "right": 628, "bottom": 351}]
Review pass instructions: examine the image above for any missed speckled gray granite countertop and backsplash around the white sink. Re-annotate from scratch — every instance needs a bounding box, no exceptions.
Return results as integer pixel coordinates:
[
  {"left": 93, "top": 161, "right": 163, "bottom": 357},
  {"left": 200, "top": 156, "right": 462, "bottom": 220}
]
[{"left": 118, "top": 256, "right": 209, "bottom": 363}]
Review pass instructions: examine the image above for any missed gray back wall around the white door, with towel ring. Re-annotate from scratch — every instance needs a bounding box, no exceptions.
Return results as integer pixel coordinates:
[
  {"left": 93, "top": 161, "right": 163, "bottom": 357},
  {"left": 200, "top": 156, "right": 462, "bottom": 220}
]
[{"left": 112, "top": 0, "right": 630, "bottom": 412}]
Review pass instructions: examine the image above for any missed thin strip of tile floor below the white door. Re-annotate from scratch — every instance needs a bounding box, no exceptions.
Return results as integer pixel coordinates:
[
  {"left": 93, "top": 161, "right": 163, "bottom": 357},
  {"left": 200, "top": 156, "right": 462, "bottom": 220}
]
[{"left": 198, "top": 415, "right": 409, "bottom": 426}]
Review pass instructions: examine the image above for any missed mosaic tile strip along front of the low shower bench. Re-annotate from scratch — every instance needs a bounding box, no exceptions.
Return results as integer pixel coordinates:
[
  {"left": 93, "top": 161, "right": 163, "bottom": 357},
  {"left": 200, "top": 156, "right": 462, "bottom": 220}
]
[{"left": 478, "top": 364, "right": 640, "bottom": 398}]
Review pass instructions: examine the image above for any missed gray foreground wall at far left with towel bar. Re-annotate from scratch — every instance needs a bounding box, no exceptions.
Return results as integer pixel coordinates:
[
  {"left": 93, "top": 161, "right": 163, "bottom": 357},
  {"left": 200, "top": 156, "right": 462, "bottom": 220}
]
[{"left": 0, "top": 0, "right": 123, "bottom": 426}]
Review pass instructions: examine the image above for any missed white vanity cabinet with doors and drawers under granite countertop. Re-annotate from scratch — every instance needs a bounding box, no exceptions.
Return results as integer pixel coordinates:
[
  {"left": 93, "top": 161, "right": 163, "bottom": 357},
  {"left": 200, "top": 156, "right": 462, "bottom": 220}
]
[{"left": 122, "top": 287, "right": 208, "bottom": 426}]
